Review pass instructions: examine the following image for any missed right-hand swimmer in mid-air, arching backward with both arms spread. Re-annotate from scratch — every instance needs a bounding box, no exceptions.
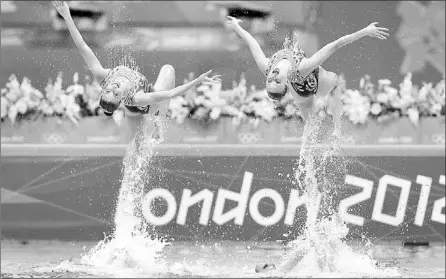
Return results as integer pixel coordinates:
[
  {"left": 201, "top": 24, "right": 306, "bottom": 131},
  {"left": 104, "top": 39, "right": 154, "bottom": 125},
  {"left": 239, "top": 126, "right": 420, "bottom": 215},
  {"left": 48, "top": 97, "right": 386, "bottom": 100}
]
[{"left": 227, "top": 16, "right": 389, "bottom": 138}]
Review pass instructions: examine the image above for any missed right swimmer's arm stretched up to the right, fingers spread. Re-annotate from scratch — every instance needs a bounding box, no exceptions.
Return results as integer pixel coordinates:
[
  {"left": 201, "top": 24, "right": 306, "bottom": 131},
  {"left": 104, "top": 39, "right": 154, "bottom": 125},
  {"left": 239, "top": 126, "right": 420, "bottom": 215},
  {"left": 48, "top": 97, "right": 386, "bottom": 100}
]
[{"left": 299, "top": 22, "right": 389, "bottom": 76}]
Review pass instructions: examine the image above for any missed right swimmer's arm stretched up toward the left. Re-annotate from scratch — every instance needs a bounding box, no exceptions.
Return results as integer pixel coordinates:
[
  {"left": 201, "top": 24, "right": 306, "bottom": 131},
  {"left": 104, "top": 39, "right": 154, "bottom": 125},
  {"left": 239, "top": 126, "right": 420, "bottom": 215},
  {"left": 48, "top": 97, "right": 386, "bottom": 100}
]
[{"left": 227, "top": 16, "right": 269, "bottom": 75}]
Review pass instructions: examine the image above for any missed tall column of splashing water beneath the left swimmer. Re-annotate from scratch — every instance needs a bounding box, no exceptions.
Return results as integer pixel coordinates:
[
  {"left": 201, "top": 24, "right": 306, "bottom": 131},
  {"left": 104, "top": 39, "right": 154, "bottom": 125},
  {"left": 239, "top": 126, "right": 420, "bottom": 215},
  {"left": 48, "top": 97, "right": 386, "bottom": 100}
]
[{"left": 81, "top": 118, "right": 169, "bottom": 274}]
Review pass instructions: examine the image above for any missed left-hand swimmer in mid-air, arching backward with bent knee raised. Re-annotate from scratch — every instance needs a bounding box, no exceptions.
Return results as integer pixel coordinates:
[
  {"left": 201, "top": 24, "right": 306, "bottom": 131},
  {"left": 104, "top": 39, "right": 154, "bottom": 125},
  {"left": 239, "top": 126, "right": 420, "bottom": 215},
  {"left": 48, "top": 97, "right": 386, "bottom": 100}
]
[{"left": 52, "top": 1, "right": 221, "bottom": 137}]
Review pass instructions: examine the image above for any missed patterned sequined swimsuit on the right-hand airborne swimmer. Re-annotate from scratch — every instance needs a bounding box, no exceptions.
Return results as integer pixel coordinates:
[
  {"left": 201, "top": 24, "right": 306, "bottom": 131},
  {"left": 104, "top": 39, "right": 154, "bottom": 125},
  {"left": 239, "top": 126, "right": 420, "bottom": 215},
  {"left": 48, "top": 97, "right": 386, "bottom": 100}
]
[{"left": 266, "top": 48, "right": 319, "bottom": 99}]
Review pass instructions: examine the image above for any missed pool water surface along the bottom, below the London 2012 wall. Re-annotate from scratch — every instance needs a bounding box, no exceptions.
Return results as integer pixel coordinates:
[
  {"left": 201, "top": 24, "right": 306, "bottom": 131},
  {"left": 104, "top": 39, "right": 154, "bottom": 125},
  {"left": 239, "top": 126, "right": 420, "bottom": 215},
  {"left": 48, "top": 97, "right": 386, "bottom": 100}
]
[{"left": 1, "top": 240, "right": 445, "bottom": 278}]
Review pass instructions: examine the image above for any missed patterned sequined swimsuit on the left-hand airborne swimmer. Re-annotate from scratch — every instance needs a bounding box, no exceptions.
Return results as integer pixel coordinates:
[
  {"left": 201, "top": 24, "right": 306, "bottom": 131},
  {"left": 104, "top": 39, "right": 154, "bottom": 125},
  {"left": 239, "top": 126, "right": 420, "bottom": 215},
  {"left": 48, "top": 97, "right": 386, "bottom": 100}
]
[{"left": 101, "top": 66, "right": 154, "bottom": 114}]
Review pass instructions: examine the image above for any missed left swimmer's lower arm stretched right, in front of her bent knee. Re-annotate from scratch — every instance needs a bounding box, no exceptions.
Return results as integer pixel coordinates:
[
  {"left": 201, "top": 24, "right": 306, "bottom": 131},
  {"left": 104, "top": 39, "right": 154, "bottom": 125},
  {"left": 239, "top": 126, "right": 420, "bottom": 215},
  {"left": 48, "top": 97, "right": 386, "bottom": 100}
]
[{"left": 134, "top": 70, "right": 221, "bottom": 106}]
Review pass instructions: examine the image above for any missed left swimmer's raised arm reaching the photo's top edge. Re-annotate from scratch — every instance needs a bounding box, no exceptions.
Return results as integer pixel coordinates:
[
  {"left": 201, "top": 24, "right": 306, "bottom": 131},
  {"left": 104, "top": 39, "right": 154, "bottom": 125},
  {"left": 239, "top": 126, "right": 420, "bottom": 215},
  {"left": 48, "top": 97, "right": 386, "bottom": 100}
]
[{"left": 52, "top": 1, "right": 108, "bottom": 80}]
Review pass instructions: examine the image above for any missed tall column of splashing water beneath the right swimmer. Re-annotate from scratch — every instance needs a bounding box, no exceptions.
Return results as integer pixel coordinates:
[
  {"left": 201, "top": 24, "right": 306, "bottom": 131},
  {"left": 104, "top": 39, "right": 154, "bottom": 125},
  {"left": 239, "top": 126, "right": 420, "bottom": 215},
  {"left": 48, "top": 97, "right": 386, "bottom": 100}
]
[{"left": 279, "top": 103, "right": 398, "bottom": 277}]
